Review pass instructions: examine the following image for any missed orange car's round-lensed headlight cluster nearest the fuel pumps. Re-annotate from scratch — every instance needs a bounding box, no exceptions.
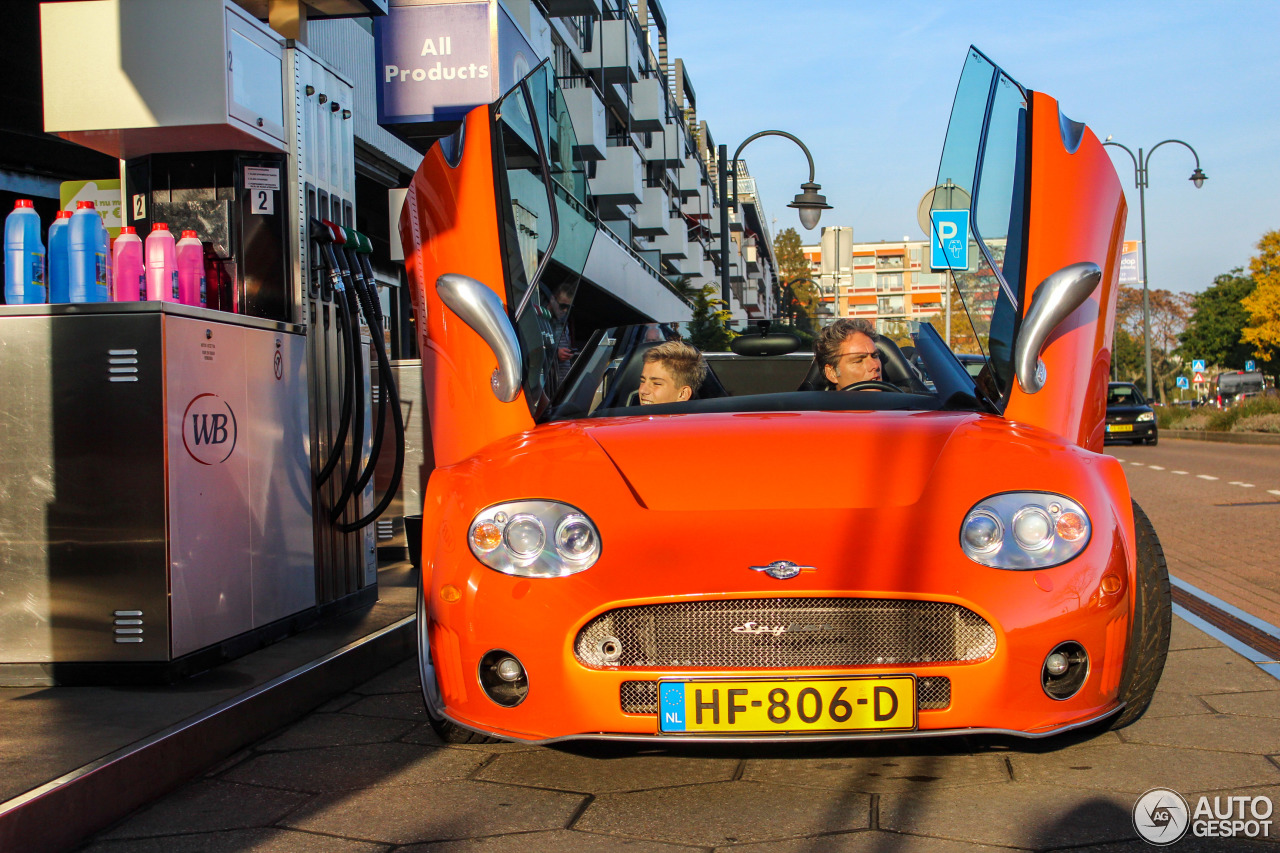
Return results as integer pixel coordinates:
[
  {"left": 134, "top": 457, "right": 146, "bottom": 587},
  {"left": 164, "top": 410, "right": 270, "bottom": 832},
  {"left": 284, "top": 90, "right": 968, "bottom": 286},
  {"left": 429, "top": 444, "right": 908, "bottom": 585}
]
[{"left": 467, "top": 501, "right": 600, "bottom": 578}]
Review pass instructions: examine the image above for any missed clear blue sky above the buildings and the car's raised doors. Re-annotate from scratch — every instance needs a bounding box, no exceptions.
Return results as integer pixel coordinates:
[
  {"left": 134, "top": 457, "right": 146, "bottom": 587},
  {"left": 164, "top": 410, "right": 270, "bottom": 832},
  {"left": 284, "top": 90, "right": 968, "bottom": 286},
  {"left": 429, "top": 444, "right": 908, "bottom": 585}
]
[{"left": 663, "top": 0, "right": 1280, "bottom": 292}]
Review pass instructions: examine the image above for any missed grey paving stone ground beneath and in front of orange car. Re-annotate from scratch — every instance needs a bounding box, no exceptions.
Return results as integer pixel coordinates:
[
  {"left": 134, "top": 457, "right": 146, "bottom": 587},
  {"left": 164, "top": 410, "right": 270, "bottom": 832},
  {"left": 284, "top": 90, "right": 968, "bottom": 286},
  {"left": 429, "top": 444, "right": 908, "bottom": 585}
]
[{"left": 72, "top": 620, "right": 1280, "bottom": 853}]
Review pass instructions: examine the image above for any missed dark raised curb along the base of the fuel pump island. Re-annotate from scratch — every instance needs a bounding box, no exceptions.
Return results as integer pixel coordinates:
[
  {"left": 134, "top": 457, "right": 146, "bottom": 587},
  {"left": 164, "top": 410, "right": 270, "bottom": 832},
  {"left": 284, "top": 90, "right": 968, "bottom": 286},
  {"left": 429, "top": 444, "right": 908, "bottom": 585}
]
[{"left": 0, "top": 616, "right": 417, "bottom": 853}]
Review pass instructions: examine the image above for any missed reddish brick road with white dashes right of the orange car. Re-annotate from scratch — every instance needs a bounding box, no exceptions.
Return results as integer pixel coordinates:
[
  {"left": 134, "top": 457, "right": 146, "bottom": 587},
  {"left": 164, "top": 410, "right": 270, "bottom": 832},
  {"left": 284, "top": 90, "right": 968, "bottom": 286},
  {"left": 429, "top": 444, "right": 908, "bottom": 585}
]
[{"left": 1107, "top": 438, "right": 1280, "bottom": 625}]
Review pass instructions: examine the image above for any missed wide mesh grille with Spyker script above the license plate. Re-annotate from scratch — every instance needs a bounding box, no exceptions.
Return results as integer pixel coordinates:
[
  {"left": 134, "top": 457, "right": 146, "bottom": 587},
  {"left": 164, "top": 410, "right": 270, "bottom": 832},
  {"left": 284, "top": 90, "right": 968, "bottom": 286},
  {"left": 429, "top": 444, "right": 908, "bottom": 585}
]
[{"left": 575, "top": 598, "right": 996, "bottom": 669}]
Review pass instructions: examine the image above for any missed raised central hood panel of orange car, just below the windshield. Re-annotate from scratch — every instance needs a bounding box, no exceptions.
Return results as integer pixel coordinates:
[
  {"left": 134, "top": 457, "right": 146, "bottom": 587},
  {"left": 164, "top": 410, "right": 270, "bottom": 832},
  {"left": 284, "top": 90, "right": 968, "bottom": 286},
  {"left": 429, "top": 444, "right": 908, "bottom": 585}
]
[{"left": 579, "top": 411, "right": 995, "bottom": 510}]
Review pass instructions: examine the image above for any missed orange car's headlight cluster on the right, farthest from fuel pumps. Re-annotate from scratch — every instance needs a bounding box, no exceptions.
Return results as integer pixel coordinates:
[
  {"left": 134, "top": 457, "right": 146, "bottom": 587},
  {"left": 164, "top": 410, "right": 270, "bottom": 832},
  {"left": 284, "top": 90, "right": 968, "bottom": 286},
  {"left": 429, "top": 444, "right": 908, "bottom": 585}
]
[{"left": 960, "top": 492, "right": 1092, "bottom": 569}]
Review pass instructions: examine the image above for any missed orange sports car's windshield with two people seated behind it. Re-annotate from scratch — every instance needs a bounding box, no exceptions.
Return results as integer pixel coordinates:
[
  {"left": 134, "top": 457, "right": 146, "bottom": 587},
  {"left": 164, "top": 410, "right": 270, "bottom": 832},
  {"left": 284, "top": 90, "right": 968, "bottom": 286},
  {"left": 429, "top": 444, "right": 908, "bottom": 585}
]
[{"left": 540, "top": 313, "right": 991, "bottom": 421}]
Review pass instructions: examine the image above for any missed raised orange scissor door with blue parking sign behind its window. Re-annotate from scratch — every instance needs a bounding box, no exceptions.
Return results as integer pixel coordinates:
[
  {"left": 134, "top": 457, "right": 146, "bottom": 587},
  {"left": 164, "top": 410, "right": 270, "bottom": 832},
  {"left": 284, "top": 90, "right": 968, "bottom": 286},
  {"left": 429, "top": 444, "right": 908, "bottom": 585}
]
[{"left": 932, "top": 49, "right": 1126, "bottom": 450}]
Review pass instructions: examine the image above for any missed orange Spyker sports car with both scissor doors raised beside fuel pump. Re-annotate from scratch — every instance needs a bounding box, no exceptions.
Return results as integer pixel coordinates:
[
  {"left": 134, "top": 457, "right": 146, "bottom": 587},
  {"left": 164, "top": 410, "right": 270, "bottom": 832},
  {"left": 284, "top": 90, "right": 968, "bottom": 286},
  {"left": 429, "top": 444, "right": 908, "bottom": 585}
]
[{"left": 401, "top": 50, "right": 1171, "bottom": 743}]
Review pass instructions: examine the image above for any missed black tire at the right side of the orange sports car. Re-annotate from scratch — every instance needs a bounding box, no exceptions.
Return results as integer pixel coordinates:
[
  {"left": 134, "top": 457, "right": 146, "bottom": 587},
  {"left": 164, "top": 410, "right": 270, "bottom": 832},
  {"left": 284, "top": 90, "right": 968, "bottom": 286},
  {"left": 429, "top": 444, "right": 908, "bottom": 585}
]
[{"left": 1111, "top": 502, "right": 1174, "bottom": 729}]
